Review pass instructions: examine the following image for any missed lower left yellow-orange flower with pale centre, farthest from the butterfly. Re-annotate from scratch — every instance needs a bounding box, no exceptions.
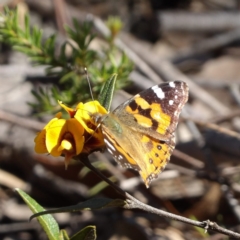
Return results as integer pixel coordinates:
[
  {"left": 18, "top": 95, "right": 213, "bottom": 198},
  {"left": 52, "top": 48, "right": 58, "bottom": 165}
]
[{"left": 34, "top": 113, "right": 84, "bottom": 166}]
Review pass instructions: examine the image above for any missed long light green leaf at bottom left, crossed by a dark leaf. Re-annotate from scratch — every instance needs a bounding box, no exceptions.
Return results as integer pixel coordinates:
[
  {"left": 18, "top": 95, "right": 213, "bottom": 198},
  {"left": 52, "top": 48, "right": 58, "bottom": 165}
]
[{"left": 15, "top": 188, "right": 61, "bottom": 240}]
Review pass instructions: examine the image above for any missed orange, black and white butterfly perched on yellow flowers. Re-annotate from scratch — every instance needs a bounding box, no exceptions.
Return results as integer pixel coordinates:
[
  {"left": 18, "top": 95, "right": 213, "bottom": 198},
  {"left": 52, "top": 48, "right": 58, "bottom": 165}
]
[{"left": 92, "top": 81, "right": 189, "bottom": 187}]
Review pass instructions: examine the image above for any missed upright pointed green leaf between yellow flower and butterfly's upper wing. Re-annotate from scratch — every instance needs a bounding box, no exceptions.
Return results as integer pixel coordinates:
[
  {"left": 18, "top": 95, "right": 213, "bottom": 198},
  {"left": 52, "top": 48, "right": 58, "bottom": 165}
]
[{"left": 98, "top": 74, "right": 117, "bottom": 111}]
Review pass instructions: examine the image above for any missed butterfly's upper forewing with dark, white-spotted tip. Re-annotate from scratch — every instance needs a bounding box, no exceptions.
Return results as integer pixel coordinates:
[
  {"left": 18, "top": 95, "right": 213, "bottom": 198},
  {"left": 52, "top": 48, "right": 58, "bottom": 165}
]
[{"left": 113, "top": 81, "right": 188, "bottom": 141}]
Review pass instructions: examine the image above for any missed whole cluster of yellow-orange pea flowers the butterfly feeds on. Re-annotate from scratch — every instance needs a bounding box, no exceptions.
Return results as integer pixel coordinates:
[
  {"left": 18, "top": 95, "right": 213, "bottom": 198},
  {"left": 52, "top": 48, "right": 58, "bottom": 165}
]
[{"left": 35, "top": 101, "right": 107, "bottom": 167}]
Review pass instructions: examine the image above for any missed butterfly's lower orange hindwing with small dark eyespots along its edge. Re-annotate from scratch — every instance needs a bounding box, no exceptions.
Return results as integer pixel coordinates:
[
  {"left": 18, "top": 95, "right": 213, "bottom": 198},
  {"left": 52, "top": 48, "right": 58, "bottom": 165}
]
[{"left": 103, "top": 119, "right": 175, "bottom": 187}]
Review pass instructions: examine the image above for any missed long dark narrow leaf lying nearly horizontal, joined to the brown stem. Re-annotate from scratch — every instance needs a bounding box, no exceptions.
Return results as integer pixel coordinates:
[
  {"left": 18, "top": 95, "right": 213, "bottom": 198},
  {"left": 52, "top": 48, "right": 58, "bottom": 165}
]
[{"left": 30, "top": 198, "right": 126, "bottom": 219}]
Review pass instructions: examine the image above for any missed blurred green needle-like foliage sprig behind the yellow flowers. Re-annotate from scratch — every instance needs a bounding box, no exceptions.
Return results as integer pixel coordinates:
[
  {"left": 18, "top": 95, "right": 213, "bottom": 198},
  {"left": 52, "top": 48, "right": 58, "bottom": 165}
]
[{"left": 0, "top": 9, "right": 133, "bottom": 113}]
